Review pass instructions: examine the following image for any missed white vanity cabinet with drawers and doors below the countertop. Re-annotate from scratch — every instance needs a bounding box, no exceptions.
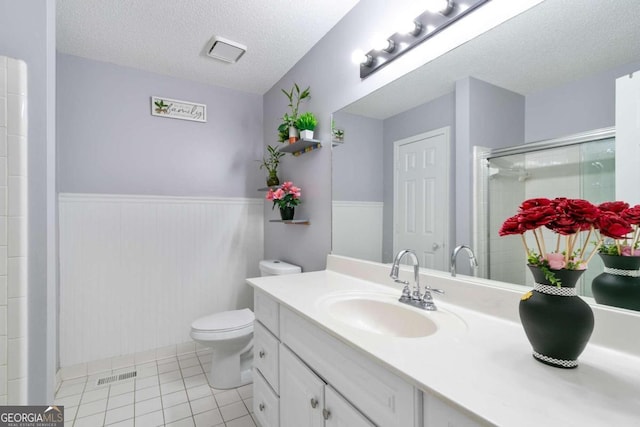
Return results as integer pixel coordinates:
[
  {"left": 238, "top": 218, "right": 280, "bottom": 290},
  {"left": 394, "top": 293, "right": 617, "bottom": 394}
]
[{"left": 253, "top": 289, "right": 422, "bottom": 427}]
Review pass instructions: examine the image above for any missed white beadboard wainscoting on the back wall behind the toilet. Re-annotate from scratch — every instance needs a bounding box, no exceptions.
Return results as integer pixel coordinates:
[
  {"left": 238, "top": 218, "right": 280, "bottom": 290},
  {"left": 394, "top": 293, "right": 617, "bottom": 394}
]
[{"left": 59, "top": 193, "right": 264, "bottom": 367}]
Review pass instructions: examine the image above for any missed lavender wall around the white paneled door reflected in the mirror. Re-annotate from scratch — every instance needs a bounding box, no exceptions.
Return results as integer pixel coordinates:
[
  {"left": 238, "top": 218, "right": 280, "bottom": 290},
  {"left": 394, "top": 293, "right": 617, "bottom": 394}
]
[{"left": 382, "top": 93, "right": 456, "bottom": 262}]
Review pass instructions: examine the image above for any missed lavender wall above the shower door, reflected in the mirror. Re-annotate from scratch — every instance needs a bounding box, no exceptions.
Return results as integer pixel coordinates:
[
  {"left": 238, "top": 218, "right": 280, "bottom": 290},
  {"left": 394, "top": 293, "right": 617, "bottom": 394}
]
[{"left": 525, "top": 61, "right": 640, "bottom": 142}]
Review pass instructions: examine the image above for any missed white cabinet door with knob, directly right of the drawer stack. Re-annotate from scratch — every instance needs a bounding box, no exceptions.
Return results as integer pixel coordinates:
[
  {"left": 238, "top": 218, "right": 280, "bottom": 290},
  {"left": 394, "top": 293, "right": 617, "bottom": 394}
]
[{"left": 280, "top": 344, "right": 324, "bottom": 427}]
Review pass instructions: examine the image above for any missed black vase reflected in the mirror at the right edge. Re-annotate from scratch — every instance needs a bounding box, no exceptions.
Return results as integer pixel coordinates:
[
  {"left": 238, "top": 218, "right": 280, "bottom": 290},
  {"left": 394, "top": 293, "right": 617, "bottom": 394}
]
[{"left": 591, "top": 254, "right": 640, "bottom": 310}]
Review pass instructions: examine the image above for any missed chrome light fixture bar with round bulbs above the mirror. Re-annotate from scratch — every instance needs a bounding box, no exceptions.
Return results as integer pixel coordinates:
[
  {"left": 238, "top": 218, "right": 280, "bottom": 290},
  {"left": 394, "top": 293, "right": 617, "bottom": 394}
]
[{"left": 360, "top": 0, "right": 489, "bottom": 79}]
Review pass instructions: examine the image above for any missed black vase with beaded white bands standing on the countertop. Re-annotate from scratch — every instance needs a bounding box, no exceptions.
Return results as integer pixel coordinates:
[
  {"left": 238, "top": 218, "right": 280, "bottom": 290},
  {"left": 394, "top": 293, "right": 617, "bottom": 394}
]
[{"left": 519, "top": 265, "right": 593, "bottom": 369}]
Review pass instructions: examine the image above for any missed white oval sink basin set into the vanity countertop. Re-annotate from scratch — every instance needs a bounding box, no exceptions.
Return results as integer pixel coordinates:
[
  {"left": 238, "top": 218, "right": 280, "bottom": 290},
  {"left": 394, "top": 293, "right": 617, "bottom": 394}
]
[{"left": 320, "top": 292, "right": 466, "bottom": 338}]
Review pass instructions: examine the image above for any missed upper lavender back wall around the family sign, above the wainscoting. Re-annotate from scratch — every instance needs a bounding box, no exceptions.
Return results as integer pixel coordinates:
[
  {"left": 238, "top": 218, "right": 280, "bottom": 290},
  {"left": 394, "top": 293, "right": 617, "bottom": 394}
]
[{"left": 57, "top": 54, "right": 266, "bottom": 197}]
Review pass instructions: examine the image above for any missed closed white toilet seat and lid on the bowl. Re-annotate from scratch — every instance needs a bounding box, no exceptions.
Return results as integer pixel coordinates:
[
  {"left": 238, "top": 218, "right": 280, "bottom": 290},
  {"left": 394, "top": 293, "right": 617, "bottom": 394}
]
[{"left": 191, "top": 308, "right": 255, "bottom": 341}]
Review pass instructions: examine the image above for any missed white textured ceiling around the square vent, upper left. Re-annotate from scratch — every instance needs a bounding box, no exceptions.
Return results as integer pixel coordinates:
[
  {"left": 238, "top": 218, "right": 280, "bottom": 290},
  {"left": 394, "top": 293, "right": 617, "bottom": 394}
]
[{"left": 57, "top": 0, "right": 357, "bottom": 95}]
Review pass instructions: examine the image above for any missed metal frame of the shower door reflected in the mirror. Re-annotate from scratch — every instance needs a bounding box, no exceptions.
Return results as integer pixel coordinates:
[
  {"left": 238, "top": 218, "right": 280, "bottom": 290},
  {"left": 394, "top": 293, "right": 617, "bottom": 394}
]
[{"left": 471, "top": 127, "right": 616, "bottom": 278}]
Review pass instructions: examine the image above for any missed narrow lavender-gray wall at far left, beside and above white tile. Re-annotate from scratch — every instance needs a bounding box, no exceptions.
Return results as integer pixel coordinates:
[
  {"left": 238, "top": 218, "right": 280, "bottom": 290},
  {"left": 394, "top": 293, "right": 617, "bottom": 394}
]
[{"left": 0, "top": 0, "right": 57, "bottom": 405}]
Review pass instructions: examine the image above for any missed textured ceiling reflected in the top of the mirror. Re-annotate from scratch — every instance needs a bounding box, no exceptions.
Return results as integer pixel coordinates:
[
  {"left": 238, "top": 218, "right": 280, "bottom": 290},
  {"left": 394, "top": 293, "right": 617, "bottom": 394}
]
[{"left": 343, "top": 0, "right": 640, "bottom": 119}]
